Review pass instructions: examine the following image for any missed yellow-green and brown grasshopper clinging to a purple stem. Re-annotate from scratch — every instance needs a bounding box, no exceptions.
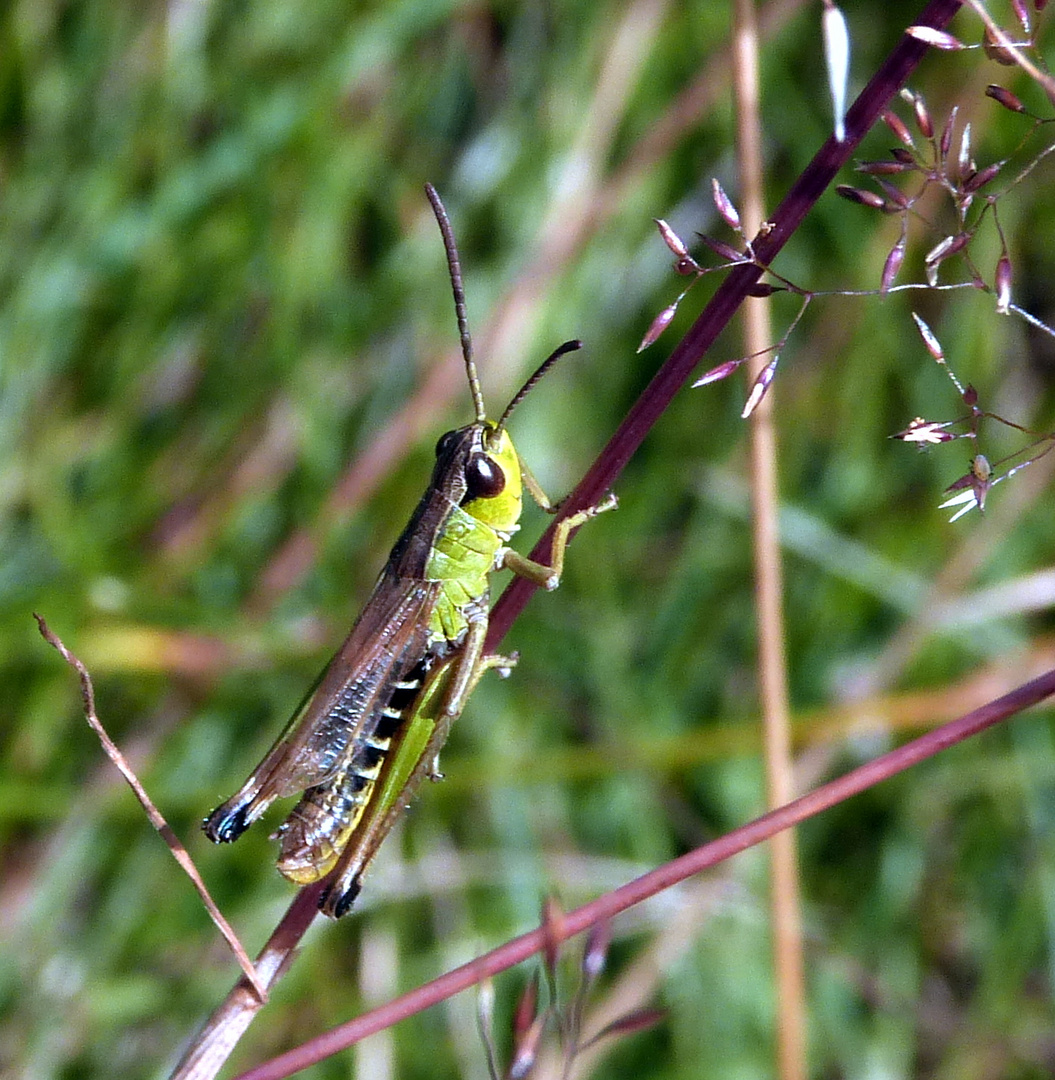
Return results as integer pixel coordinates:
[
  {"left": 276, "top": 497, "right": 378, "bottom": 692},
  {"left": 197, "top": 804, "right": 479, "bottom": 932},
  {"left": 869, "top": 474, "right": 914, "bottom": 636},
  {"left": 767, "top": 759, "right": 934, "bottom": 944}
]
[{"left": 202, "top": 185, "right": 616, "bottom": 918}]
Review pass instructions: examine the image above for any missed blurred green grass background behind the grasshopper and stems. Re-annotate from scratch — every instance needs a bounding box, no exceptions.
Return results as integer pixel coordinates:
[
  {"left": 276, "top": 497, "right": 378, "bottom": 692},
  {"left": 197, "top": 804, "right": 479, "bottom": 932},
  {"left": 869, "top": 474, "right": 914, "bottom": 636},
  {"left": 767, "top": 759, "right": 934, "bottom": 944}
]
[{"left": 0, "top": 0, "right": 1055, "bottom": 1080}]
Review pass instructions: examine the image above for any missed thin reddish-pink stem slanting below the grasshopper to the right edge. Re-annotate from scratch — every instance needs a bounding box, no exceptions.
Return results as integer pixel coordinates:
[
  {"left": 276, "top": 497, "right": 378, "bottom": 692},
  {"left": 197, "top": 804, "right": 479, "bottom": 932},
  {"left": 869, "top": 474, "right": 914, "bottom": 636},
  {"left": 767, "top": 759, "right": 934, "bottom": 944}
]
[{"left": 235, "top": 670, "right": 1055, "bottom": 1080}]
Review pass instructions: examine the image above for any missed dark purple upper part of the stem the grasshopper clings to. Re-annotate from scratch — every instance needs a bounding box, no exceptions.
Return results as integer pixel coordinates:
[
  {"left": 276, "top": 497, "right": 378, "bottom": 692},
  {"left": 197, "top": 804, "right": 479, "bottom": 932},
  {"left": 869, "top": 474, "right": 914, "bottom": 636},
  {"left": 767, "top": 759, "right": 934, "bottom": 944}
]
[{"left": 487, "top": 0, "right": 960, "bottom": 651}]
